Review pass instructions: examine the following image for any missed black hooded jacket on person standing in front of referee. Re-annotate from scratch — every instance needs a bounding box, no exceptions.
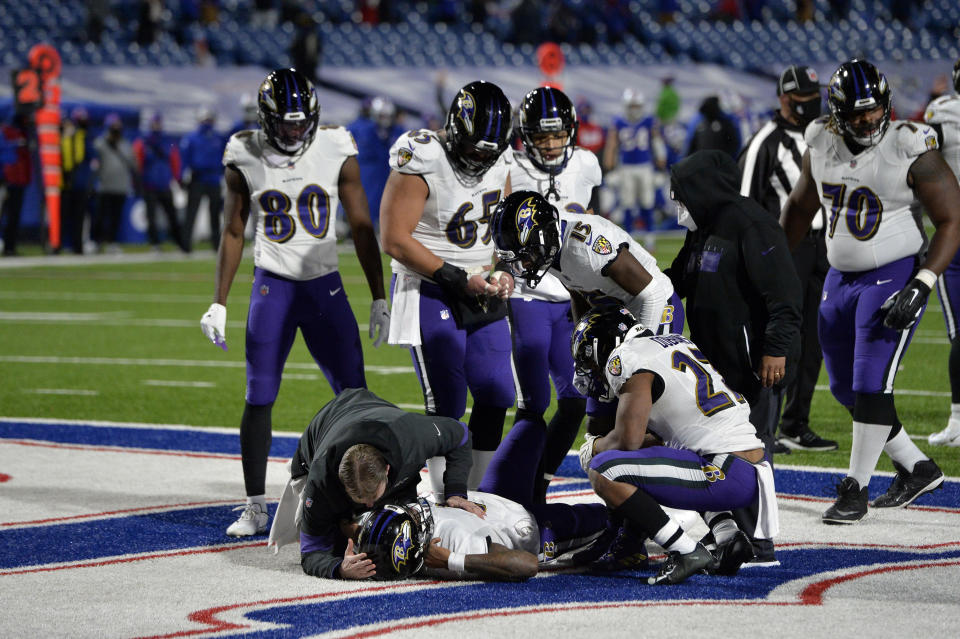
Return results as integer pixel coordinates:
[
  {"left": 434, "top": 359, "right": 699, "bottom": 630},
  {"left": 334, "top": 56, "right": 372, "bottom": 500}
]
[{"left": 666, "top": 151, "right": 801, "bottom": 404}]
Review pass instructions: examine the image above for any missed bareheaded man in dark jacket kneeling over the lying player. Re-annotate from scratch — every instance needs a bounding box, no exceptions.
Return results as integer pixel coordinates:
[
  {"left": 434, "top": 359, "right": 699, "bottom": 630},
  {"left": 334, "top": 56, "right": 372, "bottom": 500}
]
[{"left": 268, "top": 388, "right": 483, "bottom": 579}]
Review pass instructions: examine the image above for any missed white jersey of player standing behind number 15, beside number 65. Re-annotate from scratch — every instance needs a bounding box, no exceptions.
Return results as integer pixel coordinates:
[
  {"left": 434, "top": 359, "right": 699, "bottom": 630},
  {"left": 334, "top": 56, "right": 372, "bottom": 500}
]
[{"left": 504, "top": 147, "right": 601, "bottom": 302}]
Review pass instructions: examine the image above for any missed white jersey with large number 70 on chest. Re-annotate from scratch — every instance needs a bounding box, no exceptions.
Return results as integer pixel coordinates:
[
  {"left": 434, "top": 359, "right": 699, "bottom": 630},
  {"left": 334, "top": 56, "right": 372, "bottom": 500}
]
[{"left": 805, "top": 118, "right": 938, "bottom": 271}]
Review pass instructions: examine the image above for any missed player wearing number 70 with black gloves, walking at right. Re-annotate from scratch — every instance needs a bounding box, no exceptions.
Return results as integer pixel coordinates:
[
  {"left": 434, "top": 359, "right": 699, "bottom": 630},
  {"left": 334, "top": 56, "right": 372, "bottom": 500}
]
[{"left": 781, "top": 60, "right": 960, "bottom": 524}]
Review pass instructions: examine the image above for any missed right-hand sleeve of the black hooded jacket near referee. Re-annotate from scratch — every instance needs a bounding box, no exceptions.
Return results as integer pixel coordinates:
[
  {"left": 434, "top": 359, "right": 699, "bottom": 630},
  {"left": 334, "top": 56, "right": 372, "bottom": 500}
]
[{"left": 741, "top": 224, "right": 802, "bottom": 357}]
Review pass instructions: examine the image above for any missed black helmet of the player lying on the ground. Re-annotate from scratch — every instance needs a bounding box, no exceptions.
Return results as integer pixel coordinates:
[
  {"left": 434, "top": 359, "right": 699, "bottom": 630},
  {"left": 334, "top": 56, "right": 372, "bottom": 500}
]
[{"left": 357, "top": 498, "right": 433, "bottom": 581}]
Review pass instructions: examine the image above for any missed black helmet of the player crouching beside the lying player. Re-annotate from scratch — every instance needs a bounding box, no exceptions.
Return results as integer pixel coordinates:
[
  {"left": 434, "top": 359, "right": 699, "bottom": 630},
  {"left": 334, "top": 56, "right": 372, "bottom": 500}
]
[{"left": 570, "top": 304, "right": 638, "bottom": 400}]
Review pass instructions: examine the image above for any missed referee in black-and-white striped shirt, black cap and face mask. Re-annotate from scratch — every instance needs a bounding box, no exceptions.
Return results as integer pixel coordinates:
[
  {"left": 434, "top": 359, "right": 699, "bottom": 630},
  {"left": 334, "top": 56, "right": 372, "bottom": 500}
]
[{"left": 738, "top": 65, "right": 837, "bottom": 453}]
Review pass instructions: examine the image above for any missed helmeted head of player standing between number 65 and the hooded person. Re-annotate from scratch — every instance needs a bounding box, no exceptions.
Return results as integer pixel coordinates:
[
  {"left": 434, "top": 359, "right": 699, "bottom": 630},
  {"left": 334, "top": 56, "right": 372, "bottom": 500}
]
[{"left": 520, "top": 87, "right": 580, "bottom": 175}]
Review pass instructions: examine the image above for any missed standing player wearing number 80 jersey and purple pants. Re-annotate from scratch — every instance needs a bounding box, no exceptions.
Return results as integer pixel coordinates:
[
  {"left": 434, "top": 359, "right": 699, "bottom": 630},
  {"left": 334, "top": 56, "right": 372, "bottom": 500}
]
[{"left": 200, "top": 69, "right": 390, "bottom": 536}]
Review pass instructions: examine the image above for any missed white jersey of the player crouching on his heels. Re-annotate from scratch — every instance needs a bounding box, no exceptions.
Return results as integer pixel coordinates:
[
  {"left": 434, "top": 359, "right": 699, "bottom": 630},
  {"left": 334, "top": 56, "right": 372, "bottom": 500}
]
[{"left": 605, "top": 326, "right": 763, "bottom": 455}]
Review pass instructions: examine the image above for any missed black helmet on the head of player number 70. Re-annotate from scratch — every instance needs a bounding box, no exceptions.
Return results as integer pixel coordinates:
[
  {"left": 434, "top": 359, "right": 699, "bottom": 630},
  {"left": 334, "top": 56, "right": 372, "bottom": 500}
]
[{"left": 827, "top": 60, "right": 892, "bottom": 147}]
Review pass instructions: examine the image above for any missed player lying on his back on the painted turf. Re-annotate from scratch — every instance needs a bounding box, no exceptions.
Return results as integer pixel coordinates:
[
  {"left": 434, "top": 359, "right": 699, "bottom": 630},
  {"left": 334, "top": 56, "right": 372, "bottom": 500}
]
[{"left": 270, "top": 392, "right": 628, "bottom": 579}]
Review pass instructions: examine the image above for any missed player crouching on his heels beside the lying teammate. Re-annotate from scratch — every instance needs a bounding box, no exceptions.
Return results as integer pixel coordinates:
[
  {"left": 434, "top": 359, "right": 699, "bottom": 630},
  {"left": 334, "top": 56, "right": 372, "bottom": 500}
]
[{"left": 571, "top": 305, "right": 779, "bottom": 584}]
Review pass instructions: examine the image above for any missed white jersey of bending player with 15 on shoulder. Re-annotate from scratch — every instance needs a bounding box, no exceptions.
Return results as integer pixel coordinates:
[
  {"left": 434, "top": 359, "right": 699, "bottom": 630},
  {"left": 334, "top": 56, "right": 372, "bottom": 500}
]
[{"left": 550, "top": 211, "right": 673, "bottom": 329}]
